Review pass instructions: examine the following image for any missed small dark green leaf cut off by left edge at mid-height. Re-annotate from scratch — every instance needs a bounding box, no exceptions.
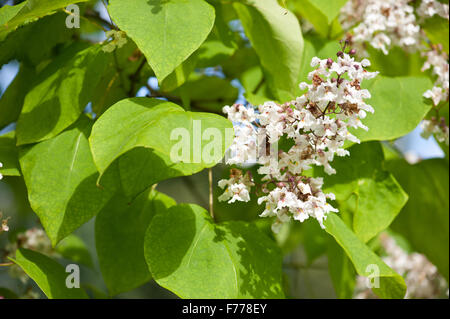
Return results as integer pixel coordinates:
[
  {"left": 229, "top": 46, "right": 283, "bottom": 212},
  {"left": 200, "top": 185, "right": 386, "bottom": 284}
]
[{"left": 0, "top": 132, "right": 21, "bottom": 176}]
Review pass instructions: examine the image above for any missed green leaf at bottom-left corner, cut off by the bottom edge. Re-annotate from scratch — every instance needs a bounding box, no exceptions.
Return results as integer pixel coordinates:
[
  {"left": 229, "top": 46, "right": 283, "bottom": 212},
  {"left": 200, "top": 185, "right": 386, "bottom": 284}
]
[{"left": 10, "top": 248, "right": 88, "bottom": 299}]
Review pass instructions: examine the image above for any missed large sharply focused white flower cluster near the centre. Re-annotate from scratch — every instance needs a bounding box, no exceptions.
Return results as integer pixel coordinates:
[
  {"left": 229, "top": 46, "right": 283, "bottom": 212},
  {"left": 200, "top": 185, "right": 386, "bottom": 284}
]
[{"left": 219, "top": 50, "right": 378, "bottom": 232}]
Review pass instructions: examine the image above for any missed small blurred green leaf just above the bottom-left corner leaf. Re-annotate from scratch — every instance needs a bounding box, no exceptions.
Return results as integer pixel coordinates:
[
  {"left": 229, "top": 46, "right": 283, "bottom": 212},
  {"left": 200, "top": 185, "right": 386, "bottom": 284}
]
[{"left": 55, "top": 234, "right": 94, "bottom": 267}]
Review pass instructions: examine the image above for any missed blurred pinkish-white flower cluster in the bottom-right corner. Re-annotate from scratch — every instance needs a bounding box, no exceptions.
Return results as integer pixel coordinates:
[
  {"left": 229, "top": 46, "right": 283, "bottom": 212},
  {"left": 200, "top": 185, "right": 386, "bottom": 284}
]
[{"left": 356, "top": 234, "right": 448, "bottom": 299}]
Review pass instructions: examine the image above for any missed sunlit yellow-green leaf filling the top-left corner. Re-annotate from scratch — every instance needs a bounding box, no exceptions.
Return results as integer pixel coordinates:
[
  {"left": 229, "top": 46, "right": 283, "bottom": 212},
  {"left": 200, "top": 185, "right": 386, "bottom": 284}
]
[{"left": 0, "top": 0, "right": 88, "bottom": 41}]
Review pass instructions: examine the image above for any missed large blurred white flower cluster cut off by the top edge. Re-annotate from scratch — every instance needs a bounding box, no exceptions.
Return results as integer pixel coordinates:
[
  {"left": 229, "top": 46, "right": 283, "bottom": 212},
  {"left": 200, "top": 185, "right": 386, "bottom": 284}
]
[{"left": 340, "top": 0, "right": 420, "bottom": 54}]
